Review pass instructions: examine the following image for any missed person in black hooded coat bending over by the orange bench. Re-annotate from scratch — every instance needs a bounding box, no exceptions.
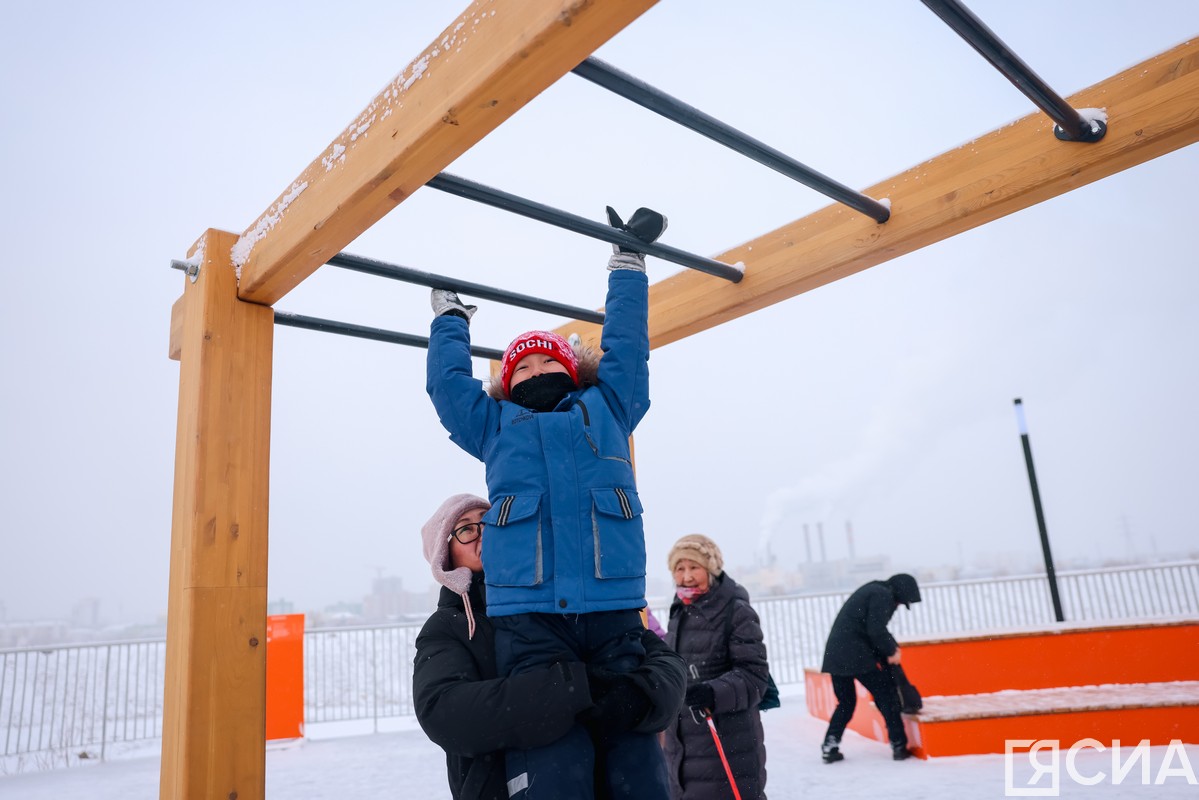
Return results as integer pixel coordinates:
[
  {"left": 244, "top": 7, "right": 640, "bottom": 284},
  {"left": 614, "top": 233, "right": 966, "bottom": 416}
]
[{"left": 820, "top": 573, "right": 920, "bottom": 764}]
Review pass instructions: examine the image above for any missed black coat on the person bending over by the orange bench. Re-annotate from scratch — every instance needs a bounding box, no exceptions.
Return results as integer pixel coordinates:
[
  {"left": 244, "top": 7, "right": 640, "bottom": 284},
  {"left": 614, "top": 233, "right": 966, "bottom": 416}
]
[{"left": 820, "top": 581, "right": 899, "bottom": 675}]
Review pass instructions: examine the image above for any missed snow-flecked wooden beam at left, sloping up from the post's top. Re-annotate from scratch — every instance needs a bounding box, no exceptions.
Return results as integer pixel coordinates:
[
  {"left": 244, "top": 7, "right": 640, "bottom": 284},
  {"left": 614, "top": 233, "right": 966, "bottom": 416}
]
[{"left": 234, "top": 0, "right": 656, "bottom": 305}]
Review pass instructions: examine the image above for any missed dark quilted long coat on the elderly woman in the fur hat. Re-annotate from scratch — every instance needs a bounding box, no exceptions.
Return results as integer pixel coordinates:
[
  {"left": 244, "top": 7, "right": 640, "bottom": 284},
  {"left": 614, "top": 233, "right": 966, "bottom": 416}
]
[{"left": 664, "top": 575, "right": 769, "bottom": 800}]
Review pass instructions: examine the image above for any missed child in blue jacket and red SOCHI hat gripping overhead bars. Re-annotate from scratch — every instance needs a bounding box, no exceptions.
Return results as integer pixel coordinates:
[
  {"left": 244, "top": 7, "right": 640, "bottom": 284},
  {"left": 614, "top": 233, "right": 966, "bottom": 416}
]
[{"left": 427, "top": 207, "right": 669, "bottom": 800}]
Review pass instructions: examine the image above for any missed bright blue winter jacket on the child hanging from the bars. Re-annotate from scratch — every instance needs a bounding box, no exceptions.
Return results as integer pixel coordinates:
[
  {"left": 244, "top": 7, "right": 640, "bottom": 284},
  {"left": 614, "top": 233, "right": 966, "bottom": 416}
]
[{"left": 426, "top": 270, "right": 650, "bottom": 616}]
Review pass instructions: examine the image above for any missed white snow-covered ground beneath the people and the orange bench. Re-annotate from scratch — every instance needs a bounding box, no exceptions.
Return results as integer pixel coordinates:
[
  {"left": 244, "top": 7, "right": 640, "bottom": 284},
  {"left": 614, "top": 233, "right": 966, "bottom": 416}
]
[{"left": 0, "top": 686, "right": 1199, "bottom": 800}]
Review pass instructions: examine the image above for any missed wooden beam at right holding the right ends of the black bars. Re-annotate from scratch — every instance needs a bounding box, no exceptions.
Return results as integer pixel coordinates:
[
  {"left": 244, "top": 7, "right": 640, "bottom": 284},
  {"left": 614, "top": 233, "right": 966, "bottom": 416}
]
[{"left": 559, "top": 37, "right": 1199, "bottom": 347}]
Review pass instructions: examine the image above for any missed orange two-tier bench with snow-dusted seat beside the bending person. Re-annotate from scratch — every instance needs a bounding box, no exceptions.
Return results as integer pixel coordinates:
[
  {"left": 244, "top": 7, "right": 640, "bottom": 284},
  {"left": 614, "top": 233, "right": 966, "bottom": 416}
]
[{"left": 805, "top": 620, "right": 1199, "bottom": 758}]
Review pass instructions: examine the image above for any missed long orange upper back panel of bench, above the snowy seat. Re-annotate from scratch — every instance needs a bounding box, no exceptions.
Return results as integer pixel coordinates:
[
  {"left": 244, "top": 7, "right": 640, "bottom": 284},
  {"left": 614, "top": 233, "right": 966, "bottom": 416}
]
[{"left": 903, "top": 624, "right": 1199, "bottom": 697}]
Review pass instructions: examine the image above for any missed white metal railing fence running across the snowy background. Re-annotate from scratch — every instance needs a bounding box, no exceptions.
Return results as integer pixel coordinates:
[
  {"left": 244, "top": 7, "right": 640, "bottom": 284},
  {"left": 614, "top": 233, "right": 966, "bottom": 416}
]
[{"left": 0, "top": 561, "right": 1199, "bottom": 774}]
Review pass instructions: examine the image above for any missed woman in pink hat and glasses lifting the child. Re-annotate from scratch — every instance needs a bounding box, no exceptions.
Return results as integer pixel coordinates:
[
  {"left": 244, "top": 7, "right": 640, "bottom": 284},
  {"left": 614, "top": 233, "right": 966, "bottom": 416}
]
[{"left": 412, "top": 494, "right": 687, "bottom": 800}]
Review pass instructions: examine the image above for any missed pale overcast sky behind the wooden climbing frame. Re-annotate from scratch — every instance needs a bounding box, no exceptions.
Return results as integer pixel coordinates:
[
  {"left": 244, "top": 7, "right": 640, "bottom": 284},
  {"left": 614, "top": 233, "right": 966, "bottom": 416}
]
[{"left": 0, "top": 0, "right": 1199, "bottom": 621}]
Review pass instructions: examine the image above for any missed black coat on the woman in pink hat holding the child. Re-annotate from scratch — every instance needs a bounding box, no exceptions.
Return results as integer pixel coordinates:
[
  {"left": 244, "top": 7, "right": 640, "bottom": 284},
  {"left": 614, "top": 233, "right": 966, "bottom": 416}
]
[{"left": 412, "top": 575, "right": 686, "bottom": 800}]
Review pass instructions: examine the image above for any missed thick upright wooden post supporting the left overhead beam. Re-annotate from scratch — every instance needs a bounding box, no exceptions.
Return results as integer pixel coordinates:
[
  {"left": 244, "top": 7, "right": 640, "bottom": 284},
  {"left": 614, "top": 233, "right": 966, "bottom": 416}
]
[{"left": 159, "top": 230, "right": 273, "bottom": 800}]
